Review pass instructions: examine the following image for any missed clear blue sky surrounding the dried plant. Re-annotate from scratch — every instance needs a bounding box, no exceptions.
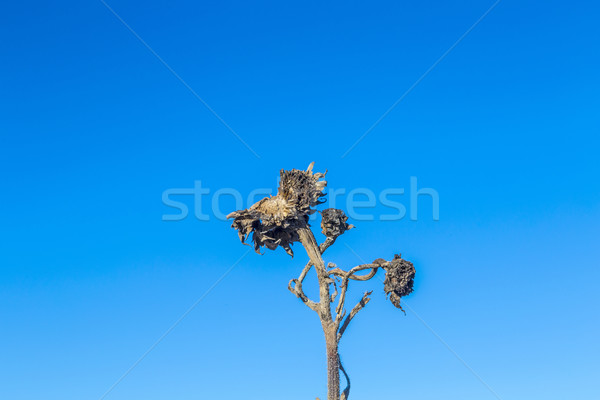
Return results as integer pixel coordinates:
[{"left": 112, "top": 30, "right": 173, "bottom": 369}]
[{"left": 0, "top": 0, "right": 600, "bottom": 400}]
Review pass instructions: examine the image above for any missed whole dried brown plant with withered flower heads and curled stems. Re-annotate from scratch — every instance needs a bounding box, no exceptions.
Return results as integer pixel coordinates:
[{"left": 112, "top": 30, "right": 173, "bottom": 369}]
[{"left": 227, "top": 163, "right": 415, "bottom": 400}]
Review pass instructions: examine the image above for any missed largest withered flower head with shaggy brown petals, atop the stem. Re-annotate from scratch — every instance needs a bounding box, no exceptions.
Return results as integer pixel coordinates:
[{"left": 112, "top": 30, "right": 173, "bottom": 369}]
[{"left": 227, "top": 163, "right": 327, "bottom": 257}]
